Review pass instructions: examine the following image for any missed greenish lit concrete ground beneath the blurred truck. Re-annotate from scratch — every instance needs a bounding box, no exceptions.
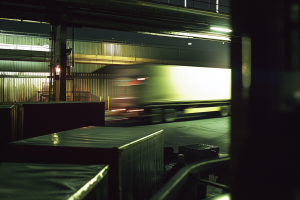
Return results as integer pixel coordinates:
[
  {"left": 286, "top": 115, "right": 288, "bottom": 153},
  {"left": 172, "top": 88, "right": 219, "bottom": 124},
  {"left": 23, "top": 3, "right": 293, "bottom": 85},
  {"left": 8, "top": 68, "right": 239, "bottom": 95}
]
[{"left": 106, "top": 115, "right": 231, "bottom": 154}]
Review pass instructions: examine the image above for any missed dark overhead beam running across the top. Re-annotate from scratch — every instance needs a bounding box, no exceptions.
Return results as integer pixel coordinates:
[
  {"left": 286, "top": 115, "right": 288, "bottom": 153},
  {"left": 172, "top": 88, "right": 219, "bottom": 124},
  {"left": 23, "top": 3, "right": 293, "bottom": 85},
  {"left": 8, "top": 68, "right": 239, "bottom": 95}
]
[{"left": 0, "top": 0, "right": 230, "bottom": 37}]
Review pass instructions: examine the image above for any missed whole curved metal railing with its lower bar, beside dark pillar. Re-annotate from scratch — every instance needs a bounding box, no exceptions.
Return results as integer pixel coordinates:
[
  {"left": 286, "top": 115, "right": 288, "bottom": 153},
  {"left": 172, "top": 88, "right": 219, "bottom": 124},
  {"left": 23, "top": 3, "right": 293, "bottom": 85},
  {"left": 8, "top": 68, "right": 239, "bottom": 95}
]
[{"left": 150, "top": 157, "right": 230, "bottom": 200}]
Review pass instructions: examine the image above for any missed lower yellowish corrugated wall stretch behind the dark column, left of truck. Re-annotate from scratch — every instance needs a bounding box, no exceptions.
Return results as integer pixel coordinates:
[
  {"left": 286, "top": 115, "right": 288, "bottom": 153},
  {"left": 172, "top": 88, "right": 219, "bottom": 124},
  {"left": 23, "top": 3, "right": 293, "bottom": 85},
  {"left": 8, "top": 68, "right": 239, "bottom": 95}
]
[{"left": 0, "top": 72, "right": 115, "bottom": 102}]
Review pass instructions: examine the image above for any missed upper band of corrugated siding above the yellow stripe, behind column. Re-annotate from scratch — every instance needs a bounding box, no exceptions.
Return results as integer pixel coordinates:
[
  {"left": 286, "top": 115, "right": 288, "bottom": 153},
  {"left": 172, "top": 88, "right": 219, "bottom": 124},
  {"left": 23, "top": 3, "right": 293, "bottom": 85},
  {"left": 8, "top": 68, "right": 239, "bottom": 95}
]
[{"left": 0, "top": 34, "right": 212, "bottom": 64}]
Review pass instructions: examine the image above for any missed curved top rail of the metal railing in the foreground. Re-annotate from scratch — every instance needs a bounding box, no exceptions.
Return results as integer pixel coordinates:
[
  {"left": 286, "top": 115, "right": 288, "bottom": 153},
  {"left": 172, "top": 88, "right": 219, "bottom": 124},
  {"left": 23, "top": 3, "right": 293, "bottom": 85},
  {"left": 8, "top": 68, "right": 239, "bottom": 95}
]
[{"left": 150, "top": 157, "right": 230, "bottom": 200}]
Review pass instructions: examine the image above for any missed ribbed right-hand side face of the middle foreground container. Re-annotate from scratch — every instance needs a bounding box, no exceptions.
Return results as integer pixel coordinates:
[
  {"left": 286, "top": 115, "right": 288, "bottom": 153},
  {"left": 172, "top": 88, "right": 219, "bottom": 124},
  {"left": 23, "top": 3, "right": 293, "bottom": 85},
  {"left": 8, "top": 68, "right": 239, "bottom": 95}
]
[{"left": 119, "top": 132, "right": 164, "bottom": 199}]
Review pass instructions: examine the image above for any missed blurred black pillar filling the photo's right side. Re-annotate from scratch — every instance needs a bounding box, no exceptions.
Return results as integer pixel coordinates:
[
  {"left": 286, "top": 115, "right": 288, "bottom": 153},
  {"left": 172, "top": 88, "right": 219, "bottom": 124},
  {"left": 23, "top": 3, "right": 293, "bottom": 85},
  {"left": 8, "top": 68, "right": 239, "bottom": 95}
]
[{"left": 231, "top": 0, "right": 300, "bottom": 200}]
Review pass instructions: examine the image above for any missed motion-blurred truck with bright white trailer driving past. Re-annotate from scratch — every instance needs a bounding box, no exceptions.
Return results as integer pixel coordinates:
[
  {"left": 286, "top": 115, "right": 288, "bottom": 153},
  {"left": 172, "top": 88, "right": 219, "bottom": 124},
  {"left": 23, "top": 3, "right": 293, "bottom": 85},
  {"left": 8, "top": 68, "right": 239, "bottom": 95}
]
[{"left": 95, "top": 64, "right": 231, "bottom": 123}]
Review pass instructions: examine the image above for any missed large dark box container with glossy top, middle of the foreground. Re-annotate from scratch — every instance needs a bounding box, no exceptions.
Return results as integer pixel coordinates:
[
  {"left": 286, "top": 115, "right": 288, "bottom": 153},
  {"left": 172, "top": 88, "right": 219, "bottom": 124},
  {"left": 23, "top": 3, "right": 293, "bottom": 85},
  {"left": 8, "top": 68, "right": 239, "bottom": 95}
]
[{"left": 4, "top": 127, "right": 164, "bottom": 200}]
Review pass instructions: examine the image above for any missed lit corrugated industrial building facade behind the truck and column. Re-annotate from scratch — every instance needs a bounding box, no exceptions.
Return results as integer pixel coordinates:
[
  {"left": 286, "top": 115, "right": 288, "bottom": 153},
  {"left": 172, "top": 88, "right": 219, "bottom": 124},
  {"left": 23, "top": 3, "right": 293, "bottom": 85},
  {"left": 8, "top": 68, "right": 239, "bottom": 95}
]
[{"left": 0, "top": 31, "right": 229, "bottom": 106}]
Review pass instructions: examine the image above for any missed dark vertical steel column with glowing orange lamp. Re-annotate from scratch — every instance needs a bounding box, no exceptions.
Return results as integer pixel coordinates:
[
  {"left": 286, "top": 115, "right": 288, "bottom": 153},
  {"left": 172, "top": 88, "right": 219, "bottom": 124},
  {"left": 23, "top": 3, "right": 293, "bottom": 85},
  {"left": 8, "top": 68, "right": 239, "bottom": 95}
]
[{"left": 54, "top": 14, "right": 67, "bottom": 101}]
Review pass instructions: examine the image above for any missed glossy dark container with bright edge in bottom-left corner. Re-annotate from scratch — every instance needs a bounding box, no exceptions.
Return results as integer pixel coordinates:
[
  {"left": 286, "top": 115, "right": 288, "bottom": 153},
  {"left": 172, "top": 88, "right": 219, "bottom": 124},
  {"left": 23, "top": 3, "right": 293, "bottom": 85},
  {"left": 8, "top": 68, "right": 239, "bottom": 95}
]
[{"left": 0, "top": 163, "right": 108, "bottom": 200}]
